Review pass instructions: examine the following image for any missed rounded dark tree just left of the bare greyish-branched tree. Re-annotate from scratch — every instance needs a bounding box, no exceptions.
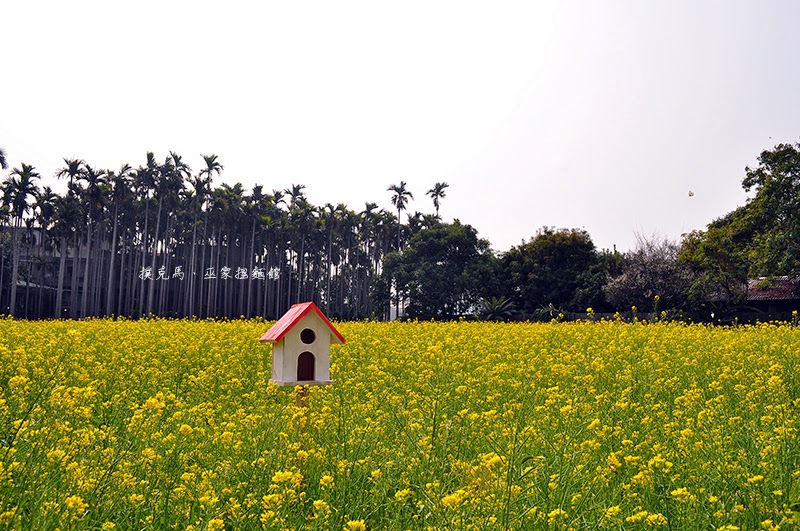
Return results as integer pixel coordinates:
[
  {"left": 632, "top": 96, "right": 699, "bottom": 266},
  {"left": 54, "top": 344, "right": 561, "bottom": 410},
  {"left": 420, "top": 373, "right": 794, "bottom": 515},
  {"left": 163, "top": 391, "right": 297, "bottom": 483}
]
[{"left": 499, "top": 227, "right": 606, "bottom": 314}]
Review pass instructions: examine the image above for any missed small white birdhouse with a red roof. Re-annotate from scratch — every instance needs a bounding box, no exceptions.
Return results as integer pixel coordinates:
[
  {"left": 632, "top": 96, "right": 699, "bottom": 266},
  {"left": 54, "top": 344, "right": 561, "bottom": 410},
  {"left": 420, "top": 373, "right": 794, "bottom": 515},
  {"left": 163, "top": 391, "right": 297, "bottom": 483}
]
[{"left": 260, "top": 302, "right": 344, "bottom": 385}]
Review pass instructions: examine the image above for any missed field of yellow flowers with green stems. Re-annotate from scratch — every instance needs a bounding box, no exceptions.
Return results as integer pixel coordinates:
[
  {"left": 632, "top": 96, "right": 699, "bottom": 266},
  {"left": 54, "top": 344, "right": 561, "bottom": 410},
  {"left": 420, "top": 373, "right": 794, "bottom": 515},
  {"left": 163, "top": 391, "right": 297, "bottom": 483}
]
[{"left": 0, "top": 319, "right": 800, "bottom": 530}]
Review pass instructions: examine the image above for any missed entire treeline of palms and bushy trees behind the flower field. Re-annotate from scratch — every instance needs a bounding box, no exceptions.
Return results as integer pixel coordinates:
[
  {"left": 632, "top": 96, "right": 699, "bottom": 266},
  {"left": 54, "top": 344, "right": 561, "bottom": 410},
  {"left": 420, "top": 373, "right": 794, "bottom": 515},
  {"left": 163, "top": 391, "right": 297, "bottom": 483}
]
[{"left": 0, "top": 144, "right": 800, "bottom": 320}]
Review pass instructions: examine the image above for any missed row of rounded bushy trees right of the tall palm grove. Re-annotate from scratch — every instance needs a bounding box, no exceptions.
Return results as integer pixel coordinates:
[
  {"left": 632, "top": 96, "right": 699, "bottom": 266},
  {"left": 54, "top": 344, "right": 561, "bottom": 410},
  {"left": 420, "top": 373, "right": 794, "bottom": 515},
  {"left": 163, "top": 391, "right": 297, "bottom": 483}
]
[{"left": 385, "top": 144, "right": 800, "bottom": 322}]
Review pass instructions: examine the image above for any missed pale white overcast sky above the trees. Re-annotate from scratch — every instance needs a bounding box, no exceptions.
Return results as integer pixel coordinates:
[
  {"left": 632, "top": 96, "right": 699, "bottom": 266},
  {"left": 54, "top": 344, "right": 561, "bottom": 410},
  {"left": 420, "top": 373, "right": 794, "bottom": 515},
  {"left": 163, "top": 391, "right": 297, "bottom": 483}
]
[{"left": 0, "top": 0, "right": 800, "bottom": 251}]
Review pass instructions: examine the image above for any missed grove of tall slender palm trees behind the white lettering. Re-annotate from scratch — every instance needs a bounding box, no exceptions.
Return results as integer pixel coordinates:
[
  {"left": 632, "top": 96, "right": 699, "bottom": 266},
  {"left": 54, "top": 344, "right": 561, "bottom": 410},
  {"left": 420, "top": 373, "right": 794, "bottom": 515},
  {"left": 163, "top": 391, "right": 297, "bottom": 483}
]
[{"left": 0, "top": 153, "right": 438, "bottom": 319}]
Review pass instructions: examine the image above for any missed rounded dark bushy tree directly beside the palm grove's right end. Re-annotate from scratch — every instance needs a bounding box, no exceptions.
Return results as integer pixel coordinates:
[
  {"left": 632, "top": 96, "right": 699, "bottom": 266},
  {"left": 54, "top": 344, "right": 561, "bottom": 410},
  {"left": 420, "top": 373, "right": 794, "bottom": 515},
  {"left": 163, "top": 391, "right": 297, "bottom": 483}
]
[{"left": 384, "top": 220, "right": 494, "bottom": 319}]
